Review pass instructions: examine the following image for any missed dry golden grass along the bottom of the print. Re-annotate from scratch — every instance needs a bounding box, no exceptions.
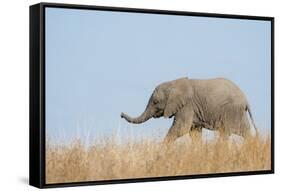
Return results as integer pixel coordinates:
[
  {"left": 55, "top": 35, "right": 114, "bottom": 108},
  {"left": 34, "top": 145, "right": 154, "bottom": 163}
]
[{"left": 46, "top": 137, "right": 271, "bottom": 183}]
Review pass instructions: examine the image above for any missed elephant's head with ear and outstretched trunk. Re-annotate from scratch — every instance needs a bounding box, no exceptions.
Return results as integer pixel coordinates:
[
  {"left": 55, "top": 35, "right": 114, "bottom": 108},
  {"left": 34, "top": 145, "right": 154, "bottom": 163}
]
[{"left": 121, "top": 78, "right": 192, "bottom": 124}]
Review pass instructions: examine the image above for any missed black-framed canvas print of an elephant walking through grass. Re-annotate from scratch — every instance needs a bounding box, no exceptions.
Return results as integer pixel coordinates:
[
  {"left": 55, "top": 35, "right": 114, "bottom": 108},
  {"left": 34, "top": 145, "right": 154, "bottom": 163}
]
[{"left": 30, "top": 3, "right": 274, "bottom": 188}]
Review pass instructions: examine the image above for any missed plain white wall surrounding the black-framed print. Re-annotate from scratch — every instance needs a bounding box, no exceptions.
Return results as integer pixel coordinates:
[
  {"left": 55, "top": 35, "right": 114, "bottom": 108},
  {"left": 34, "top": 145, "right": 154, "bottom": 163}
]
[{"left": 0, "top": 0, "right": 276, "bottom": 191}]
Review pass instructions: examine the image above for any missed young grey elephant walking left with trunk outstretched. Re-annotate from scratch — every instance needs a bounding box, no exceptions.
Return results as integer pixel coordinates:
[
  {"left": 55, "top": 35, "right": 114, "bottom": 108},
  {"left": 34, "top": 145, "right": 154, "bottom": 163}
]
[{"left": 121, "top": 77, "right": 257, "bottom": 143}]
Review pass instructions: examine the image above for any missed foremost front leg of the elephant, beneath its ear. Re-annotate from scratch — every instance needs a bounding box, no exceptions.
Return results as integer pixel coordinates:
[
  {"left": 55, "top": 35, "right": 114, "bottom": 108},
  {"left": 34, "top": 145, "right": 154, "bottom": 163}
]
[{"left": 164, "top": 109, "right": 193, "bottom": 143}]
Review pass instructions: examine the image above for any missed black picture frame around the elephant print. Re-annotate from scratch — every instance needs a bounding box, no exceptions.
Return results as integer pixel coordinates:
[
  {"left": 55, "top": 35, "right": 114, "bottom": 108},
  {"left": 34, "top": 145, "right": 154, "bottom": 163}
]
[{"left": 29, "top": 3, "right": 274, "bottom": 188}]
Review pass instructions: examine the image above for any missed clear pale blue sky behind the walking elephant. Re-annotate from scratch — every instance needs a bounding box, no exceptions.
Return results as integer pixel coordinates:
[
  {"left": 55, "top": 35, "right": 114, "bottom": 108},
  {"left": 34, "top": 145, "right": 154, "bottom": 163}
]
[{"left": 46, "top": 8, "right": 271, "bottom": 145}]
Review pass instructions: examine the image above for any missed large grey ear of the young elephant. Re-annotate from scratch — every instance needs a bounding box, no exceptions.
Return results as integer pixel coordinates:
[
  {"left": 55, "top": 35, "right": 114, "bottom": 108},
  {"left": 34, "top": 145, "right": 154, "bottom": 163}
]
[{"left": 164, "top": 80, "right": 192, "bottom": 118}]
